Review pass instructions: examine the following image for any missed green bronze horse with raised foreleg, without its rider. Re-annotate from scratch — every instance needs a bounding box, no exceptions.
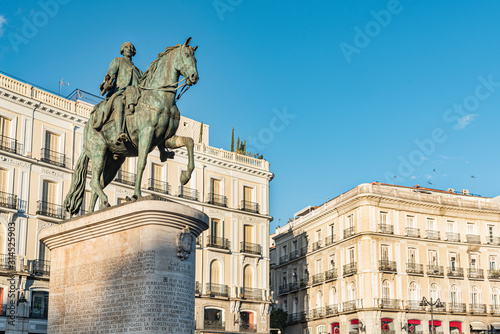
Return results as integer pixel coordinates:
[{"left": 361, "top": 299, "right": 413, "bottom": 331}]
[{"left": 64, "top": 38, "right": 199, "bottom": 215}]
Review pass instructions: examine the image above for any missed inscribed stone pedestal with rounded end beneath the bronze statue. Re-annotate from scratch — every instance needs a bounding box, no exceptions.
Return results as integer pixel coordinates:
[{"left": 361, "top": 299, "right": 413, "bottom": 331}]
[{"left": 40, "top": 200, "right": 208, "bottom": 334}]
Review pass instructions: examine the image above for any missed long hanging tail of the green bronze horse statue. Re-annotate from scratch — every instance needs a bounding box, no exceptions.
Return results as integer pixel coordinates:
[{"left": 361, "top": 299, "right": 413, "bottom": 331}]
[{"left": 64, "top": 151, "right": 89, "bottom": 215}]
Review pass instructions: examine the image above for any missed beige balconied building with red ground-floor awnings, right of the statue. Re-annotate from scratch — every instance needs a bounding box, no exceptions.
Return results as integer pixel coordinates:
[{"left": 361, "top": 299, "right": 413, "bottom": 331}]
[{"left": 270, "top": 183, "right": 500, "bottom": 334}]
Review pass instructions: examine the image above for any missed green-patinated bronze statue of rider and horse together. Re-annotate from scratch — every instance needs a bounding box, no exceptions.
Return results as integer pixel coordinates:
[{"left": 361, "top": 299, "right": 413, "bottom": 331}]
[{"left": 64, "top": 37, "right": 199, "bottom": 215}]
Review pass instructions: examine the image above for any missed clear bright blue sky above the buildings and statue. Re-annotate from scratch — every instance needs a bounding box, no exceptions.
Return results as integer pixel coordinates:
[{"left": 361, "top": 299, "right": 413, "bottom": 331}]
[{"left": 0, "top": 0, "right": 500, "bottom": 230}]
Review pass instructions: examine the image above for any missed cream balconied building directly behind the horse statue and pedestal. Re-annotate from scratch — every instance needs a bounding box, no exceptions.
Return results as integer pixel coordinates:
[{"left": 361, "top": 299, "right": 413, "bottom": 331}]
[{"left": 0, "top": 75, "right": 274, "bottom": 334}]
